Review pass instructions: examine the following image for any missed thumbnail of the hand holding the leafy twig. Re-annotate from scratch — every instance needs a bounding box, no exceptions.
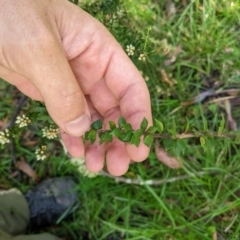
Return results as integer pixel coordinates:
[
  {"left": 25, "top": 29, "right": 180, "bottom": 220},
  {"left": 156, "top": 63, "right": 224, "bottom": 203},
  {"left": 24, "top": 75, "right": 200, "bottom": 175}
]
[{"left": 65, "top": 114, "right": 91, "bottom": 137}]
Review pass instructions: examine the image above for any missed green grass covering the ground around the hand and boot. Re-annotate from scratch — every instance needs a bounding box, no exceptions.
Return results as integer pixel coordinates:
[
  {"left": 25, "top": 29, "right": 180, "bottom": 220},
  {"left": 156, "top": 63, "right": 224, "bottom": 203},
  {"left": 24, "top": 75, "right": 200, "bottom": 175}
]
[{"left": 0, "top": 0, "right": 240, "bottom": 240}]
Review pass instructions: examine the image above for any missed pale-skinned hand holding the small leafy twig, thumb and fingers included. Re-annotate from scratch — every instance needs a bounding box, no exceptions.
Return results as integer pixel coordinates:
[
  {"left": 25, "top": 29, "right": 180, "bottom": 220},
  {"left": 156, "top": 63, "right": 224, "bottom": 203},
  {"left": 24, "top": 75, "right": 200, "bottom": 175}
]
[{"left": 0, "top": 0, "right": 152, "bottom": 176}]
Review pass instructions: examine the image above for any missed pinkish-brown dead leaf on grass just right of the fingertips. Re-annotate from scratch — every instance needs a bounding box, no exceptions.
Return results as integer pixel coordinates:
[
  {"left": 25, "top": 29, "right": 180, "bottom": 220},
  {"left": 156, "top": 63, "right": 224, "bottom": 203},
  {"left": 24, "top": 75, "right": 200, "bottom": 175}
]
[{"left": 154, "top": 142, "right": 182, "bottom": 169}]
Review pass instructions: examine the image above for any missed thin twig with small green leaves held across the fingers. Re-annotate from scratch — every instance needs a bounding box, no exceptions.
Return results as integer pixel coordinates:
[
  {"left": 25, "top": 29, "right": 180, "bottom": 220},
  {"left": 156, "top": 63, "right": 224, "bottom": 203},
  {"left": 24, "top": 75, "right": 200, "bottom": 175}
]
[{"left": 84, "top": 117, "right": 240, "bottom": 147}]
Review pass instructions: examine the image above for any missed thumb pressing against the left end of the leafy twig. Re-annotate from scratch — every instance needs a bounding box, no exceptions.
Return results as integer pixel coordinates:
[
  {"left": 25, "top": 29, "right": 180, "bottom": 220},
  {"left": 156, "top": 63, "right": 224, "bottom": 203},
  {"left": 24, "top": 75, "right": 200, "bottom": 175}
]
[{"left": 27, "top": 36, "right": 91, "bottom": 136}]
